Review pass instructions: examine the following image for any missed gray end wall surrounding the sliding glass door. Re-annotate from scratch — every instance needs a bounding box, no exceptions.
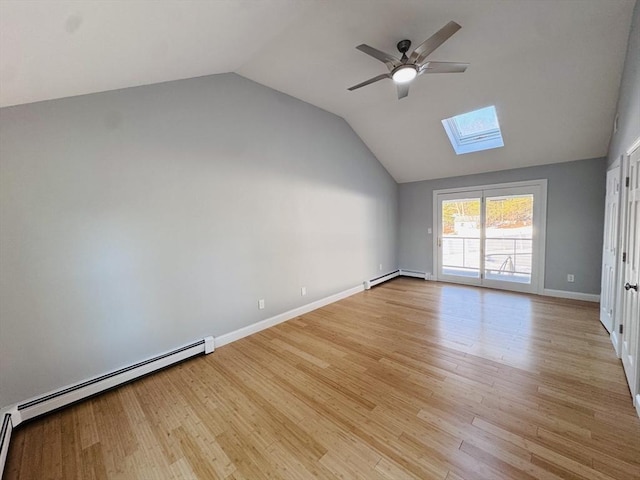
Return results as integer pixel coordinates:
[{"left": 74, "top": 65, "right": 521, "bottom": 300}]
[{"left": 398, "top": 158, "right": 606, "bottom": 294}]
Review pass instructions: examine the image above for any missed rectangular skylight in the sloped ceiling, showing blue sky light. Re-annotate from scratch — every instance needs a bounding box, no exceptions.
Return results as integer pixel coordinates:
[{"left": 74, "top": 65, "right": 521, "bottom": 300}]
[{"left": 442, "top": 105, "right": 504, "bottom": 155}]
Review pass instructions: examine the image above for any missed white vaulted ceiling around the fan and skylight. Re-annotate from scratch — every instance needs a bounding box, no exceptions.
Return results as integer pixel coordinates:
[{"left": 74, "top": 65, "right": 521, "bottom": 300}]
[{"left": 0, "top": 0, "right": 635, "bottom": 182}]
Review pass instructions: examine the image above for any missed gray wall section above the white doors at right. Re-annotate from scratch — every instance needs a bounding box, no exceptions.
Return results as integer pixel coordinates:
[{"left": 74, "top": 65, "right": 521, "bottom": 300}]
[{"left": 607, "top": 2, "right": 640, "bottom": 165}]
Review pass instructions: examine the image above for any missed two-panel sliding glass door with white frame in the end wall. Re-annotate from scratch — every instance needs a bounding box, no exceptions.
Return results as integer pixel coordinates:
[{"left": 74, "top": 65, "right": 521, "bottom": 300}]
[{"left": 434, "top": 183, "right": 546, "bottom": 293}]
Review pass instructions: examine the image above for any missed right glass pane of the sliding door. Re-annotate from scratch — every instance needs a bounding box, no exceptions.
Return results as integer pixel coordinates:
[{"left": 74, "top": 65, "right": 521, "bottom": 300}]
[{"left": 484, "top": 194, "right": 534, "bottom": 284}]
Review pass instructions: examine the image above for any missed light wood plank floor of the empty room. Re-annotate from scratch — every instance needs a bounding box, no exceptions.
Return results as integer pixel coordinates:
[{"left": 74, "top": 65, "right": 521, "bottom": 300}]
[{"left": 5, "top": 279, "right": 640, "bottom": 480}]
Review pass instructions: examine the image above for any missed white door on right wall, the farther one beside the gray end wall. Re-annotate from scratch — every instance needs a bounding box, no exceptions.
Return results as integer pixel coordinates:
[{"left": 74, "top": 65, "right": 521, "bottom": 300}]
[{"left": 600, "top": 166, "right": 620, "bottom": 333}]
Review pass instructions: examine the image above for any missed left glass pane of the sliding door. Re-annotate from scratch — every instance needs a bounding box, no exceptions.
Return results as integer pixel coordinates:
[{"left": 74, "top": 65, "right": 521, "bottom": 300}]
[{"left": 439, "top": 197, "right": 482, "bottom": 281}]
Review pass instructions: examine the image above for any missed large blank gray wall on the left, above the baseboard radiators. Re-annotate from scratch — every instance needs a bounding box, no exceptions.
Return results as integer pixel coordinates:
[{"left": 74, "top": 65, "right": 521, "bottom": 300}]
[{"left": 0, "top": 74, "right": 398, "bottom": 406}]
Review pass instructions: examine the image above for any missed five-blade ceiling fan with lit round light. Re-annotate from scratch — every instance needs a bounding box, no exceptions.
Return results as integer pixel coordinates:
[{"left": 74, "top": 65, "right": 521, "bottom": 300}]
[{"left": 349, "top": 22, "right": 469, "bottom": 99}]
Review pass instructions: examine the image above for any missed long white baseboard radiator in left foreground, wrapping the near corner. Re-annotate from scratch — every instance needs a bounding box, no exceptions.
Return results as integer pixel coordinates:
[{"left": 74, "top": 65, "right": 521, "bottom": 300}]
[{"left": 0, "top": 337, "right": 215, "bottom": 480}]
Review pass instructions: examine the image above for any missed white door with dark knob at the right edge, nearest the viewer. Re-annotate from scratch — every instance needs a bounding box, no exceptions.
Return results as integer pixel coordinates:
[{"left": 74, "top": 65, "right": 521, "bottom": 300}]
[{"left": 621, "top": 148, "right": 640, "bottom": 406}]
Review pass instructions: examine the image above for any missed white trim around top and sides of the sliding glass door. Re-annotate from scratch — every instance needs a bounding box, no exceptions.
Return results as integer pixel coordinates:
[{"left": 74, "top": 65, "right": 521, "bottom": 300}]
[{"left": 431, "top": 179, "right": 548, "bottom": 295}]
